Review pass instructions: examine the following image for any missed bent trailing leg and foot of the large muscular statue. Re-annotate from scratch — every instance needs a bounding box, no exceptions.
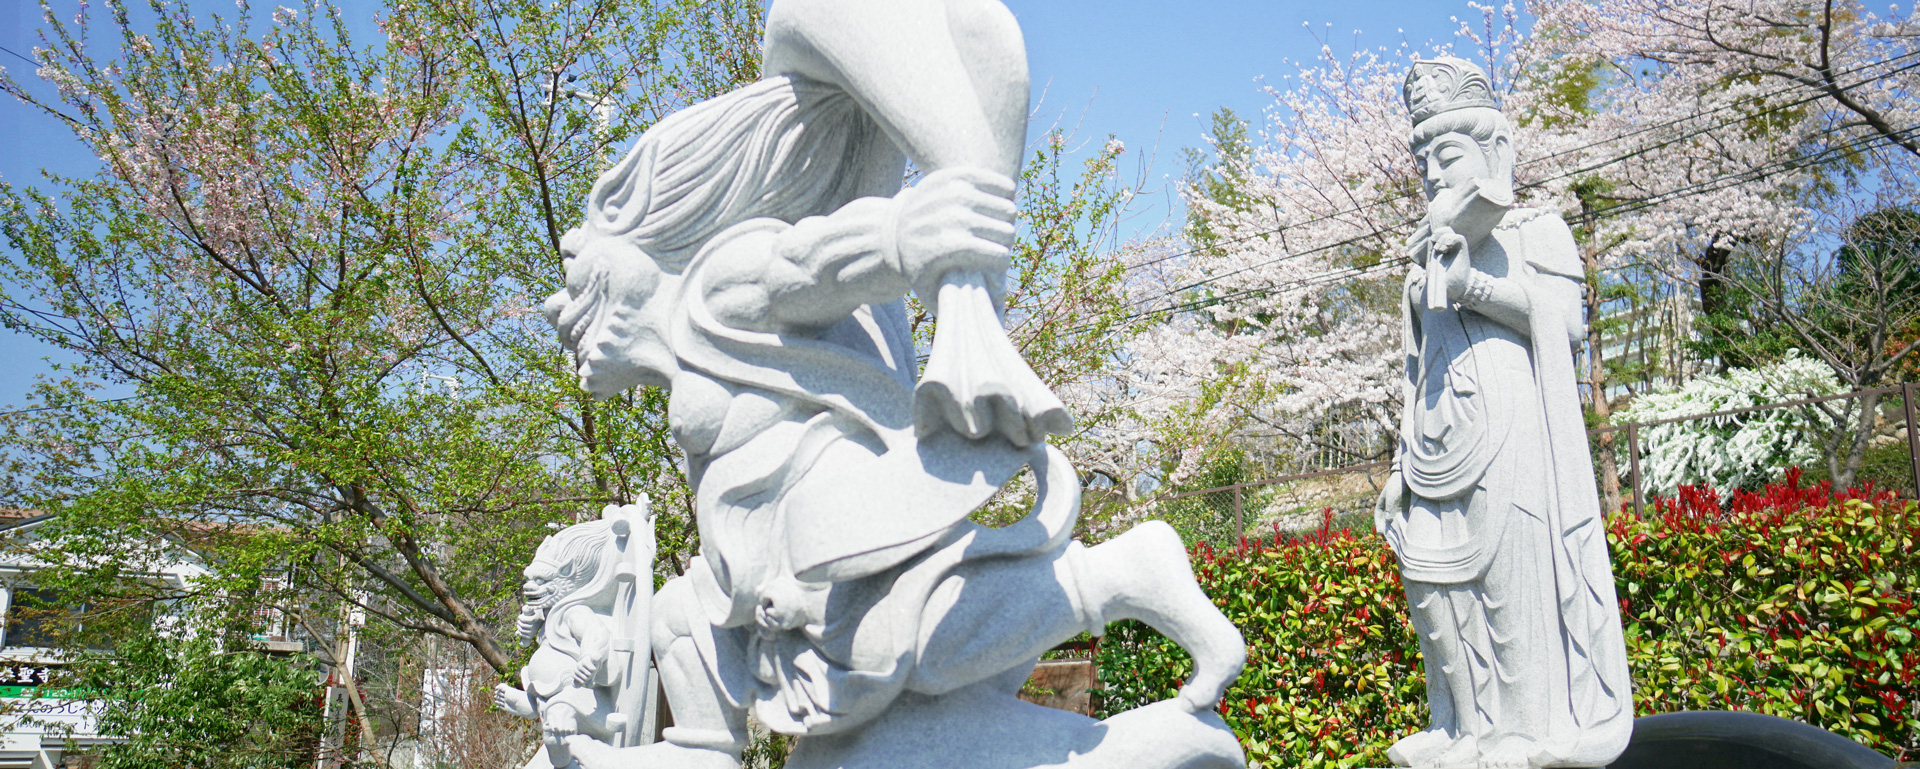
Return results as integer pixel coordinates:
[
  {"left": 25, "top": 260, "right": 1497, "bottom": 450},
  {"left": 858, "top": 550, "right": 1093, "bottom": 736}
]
[{"left": 912, "top": 522, "right": 1246, "bottom": 711}]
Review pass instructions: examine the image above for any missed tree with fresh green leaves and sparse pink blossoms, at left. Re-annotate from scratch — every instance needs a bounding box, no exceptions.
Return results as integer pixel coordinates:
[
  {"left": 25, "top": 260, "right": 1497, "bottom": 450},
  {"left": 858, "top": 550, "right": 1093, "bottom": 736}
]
[{"left": 0, "top": 0, "right": 760, "bottom": 759}]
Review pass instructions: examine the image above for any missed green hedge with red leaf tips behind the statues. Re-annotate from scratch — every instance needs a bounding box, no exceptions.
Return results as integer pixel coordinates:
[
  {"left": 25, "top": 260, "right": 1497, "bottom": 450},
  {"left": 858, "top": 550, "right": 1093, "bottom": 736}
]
[{"left": 1100, "top": 470, "right": 1920, "bottom": 767}]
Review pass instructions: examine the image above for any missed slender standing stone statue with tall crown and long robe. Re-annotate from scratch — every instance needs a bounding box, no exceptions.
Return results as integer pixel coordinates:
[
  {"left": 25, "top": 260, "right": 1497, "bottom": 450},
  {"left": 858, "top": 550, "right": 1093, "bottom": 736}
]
[{"left": 1375, "top": 58, "right": 1634, "bottom": 767}]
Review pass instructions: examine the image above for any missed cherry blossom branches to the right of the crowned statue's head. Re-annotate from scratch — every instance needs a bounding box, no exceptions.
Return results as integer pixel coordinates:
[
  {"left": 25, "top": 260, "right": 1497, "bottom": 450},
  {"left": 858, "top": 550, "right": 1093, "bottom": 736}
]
[{"left": 1534, "top": 0, "right": 1920, "bottom": 483}]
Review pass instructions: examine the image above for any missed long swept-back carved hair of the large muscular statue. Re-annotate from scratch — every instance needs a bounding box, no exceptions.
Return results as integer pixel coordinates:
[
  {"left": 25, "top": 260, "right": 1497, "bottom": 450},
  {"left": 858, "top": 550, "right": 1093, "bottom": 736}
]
[{"left": 582, "top": 77, "right": 883, "bottom": 272}]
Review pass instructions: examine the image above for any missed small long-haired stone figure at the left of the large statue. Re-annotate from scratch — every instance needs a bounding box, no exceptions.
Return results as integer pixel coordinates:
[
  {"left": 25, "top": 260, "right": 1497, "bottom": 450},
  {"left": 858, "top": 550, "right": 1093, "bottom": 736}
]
[{"left": 493, "top": 520, "right": 620, "bottom": 767}]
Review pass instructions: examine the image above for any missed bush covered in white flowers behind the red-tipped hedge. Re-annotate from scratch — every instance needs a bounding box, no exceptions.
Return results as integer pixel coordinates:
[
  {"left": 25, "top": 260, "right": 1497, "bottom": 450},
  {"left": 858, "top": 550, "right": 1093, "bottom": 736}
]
[{"left": 1615, "top": 351, "right": 1843, "bottom": 495}]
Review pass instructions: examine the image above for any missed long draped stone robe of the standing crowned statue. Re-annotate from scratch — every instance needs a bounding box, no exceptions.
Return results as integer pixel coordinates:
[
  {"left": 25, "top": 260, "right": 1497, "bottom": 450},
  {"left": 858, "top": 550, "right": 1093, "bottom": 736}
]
[{"left": 1386, "top": 209, "right": 1632, "bottom": 765}]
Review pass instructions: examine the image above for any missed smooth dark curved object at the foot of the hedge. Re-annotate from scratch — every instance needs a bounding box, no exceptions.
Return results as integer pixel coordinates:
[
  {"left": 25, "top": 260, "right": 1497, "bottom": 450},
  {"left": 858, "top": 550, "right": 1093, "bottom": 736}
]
[{"left": 1609, "top": 710, "right": 1893, "bottom": 769}]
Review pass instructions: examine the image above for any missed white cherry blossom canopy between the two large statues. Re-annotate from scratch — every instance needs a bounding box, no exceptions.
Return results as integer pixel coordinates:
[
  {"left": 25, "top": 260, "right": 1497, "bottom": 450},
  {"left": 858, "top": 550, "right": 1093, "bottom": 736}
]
[{"left": 1131, "top": 54, "right": 1417, "bottom": 483}]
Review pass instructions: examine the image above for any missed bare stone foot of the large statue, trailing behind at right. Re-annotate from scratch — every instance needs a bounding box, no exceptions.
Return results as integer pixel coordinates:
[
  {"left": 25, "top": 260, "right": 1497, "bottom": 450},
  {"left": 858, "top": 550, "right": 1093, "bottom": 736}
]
[{"left": 1083, "top": 522, "right": 1246, "bottom": 713}]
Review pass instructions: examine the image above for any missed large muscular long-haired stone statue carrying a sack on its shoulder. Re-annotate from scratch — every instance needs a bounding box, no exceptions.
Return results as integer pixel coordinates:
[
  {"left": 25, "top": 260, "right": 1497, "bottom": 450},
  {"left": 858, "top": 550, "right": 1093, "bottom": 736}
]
[{"left": 501, "top": 0, "right": 1246, "bottom": 769}]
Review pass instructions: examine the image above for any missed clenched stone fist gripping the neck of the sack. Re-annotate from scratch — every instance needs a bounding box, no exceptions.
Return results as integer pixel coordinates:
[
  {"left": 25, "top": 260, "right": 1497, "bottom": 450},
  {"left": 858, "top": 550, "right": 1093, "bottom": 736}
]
[{"left": 895, "top": 169, "right": 1016, "bottom": 301}]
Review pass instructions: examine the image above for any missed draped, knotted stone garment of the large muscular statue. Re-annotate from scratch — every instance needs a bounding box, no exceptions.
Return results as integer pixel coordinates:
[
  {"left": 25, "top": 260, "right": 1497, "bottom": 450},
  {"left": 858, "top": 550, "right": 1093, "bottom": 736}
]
[{"left": 670, "top": 219, "right": 1077, "bottom": 734}]
